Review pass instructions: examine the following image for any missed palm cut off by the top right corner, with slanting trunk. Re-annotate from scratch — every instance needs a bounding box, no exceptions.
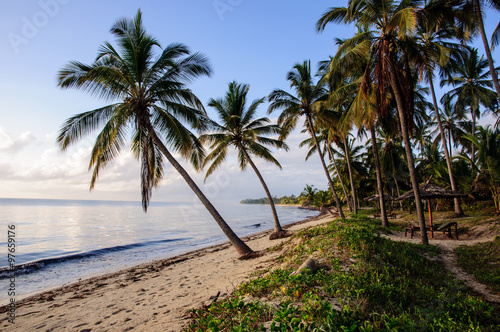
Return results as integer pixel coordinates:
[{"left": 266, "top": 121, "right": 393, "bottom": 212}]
[{"left": 459, "top": 0, "right": 500, "bottom": 101}]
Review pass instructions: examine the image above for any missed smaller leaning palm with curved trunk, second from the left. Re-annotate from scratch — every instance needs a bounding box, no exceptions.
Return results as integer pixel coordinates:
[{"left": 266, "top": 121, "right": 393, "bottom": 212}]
[{"left": 200, "top": 82, "right": 288, "bottom": 240}]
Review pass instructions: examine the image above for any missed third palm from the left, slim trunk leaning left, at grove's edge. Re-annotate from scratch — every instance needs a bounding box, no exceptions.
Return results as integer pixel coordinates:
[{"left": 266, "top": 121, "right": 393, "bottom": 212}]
[{"left": 268, "top": 61, "right": 345, "bottom": 218}]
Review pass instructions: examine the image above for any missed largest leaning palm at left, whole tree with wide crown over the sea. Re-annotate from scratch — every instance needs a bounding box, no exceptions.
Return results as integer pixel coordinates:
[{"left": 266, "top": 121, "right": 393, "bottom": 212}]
[{"left": 57, "top": 11, "right": 253, "bottom": 258}]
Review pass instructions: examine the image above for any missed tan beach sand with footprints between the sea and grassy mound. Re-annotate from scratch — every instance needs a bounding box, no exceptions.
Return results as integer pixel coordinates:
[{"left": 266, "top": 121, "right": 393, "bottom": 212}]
[{"left": 0, "top": 214, "right": 334, "bottom": 331}]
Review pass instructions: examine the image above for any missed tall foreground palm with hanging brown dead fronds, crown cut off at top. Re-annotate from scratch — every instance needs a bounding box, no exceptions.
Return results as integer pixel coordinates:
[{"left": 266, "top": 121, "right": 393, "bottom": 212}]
[{"left": 316, "top": 0, "right": 429, "bottom": 244}]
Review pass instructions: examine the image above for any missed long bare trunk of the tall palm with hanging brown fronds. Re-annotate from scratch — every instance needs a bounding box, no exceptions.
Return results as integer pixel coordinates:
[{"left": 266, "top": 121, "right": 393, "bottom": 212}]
[{"left": 389, "top": 60, "right": 429, "bottom": 245}]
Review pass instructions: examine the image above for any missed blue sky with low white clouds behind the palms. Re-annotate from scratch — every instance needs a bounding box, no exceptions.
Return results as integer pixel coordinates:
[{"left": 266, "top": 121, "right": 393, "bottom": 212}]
[{"left": 0, "top": 0, "right": 500, "bottom": 203}]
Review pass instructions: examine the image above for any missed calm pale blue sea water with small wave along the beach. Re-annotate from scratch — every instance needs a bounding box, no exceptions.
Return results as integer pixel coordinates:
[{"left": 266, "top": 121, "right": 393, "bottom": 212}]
[{"left": 0, "top": 199, "right": 316, "bottom": 303}]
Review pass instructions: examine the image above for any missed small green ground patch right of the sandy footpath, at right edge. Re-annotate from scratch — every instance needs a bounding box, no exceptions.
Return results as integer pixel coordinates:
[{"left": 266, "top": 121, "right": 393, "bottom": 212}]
[{"left": 457, "top": 237, "right": 500, "bottom": 294}]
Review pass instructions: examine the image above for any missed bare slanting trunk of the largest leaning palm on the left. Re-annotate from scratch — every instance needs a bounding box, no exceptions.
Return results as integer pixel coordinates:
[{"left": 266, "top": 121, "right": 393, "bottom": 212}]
[{"left": 149, "top": 128, "right": 254, "bottom": 258}]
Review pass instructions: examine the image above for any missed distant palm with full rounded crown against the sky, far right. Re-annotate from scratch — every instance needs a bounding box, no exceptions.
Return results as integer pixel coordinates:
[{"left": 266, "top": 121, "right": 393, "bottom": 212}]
[{"left": 441, "top": 48, "right": 498, "bottom": 163}]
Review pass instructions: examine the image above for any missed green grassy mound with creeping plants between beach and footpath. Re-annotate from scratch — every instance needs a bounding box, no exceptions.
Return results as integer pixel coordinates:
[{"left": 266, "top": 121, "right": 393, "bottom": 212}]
[{"left": 187, "top": 216, "right": 500, "bottom": 331}]
